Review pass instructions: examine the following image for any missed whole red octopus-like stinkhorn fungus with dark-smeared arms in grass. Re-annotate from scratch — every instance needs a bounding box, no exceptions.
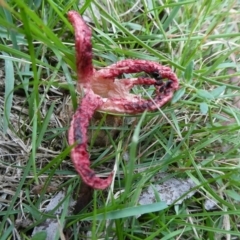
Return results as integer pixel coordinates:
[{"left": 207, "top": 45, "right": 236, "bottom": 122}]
[{"left": 68, "top": 11, "right": 179, "bottom": 189}]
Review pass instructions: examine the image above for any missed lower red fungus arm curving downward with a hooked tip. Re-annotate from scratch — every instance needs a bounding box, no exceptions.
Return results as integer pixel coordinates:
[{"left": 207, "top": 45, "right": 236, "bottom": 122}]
[{"left": 68, "top": 91, "right": 113, "bottom": 189}]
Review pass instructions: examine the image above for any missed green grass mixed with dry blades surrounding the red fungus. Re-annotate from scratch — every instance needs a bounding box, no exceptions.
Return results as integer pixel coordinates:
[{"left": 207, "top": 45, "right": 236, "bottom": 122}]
[{"left": 0, "top": 0, "right": 240, "bottom": 240}]
